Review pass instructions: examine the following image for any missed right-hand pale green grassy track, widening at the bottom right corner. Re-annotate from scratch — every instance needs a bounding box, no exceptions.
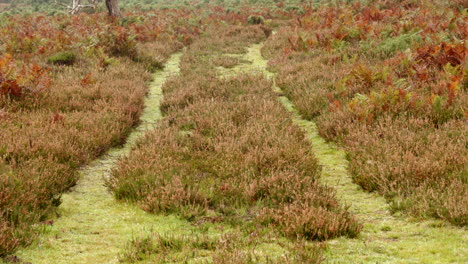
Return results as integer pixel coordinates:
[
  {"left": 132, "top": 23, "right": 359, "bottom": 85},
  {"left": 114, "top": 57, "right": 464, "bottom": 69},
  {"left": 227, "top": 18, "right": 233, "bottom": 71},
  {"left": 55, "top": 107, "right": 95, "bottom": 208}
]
[{"left": 231, "top": 44, "right": 468, "bottom": 263}]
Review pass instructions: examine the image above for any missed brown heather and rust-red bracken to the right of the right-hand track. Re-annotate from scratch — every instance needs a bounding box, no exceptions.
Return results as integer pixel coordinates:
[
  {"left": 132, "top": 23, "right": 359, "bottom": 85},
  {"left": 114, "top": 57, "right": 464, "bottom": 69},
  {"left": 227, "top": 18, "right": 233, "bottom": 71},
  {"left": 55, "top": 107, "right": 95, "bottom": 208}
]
[{"left": 262, "top": 1, "right": 468, "bottom": 226}]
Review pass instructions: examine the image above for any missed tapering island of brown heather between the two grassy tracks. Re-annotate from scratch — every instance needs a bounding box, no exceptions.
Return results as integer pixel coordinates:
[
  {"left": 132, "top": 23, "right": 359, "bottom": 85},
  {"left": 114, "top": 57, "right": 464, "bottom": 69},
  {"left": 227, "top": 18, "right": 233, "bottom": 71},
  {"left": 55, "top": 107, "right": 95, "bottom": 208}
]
[{"left": 109, "top": 25, "right": 361, "bottom": 241}]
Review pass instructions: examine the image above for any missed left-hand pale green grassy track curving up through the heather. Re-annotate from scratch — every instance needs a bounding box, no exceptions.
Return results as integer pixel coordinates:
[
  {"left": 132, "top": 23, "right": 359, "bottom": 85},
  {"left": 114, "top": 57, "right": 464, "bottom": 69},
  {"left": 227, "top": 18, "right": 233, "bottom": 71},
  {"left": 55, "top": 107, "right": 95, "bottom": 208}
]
[{"left": 12, "top": 53, "right": 192, "bottom": 264}]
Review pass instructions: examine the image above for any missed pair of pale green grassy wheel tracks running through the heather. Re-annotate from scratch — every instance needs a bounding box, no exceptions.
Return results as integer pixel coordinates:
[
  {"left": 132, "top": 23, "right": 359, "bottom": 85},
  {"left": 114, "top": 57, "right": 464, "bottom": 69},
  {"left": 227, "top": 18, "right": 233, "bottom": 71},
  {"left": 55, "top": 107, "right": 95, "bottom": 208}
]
[{"left": 9, "top": 39, "right": 468, "bottom": 264}]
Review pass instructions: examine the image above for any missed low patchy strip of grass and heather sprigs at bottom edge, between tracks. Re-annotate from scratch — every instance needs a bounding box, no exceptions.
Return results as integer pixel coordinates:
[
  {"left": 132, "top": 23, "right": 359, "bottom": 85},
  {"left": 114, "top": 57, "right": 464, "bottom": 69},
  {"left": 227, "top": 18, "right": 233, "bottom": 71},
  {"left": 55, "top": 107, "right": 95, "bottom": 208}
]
[{"left": 120, "top": 231, "right": 323, "bottom": 264}]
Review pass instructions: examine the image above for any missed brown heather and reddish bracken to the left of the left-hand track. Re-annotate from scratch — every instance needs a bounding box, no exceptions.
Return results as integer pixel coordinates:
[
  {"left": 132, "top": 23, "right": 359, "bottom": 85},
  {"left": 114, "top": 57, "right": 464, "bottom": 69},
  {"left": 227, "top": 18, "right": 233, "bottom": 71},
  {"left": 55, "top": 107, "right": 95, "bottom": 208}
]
[{"left": 0, "top": 10, "right": 218, "bottom": 257}]
